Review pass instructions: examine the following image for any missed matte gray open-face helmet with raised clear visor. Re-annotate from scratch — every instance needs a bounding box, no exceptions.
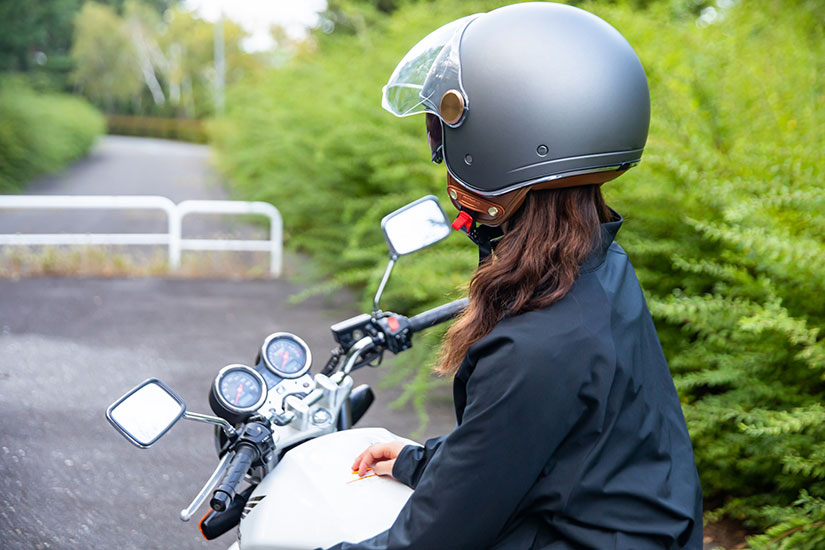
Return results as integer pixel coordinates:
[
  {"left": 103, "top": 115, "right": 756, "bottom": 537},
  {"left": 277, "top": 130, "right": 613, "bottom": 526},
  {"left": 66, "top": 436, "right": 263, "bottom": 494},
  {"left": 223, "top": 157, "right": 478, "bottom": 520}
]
[{"left": 382, "top": 2, "right": 650, "bottom": 223}]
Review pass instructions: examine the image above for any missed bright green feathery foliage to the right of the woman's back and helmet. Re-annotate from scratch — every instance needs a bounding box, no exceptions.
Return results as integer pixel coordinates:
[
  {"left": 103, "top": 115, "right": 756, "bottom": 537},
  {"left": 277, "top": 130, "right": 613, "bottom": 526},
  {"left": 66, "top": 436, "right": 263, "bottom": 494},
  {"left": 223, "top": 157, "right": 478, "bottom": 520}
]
[{"left": 608, "top": 1, "right": 825, "bottom": 548}]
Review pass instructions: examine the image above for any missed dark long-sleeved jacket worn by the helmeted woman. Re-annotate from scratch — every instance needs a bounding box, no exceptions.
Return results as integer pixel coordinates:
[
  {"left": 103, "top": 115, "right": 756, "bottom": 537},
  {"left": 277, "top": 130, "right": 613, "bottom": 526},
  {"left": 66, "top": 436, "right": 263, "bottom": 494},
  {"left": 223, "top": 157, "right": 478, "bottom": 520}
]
[{"left": 326, "top": 220, "right": 702, "bottom": 550}]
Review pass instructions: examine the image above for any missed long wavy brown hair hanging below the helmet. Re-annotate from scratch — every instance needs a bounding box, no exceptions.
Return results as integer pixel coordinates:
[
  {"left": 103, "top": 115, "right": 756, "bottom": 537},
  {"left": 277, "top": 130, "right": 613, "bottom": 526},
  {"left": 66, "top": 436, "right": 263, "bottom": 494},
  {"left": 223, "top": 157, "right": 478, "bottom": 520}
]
[{"left": 436, "top": 185, "right": 611, "bottom": 375}]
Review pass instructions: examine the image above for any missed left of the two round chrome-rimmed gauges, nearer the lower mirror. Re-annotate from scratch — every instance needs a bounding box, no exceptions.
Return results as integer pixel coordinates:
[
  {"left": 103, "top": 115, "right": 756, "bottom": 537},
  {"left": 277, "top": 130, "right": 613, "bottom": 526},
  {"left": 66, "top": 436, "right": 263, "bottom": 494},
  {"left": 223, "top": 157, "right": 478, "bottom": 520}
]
[{"left": 209, "top": 364, "right": 266, "bottom": 423}]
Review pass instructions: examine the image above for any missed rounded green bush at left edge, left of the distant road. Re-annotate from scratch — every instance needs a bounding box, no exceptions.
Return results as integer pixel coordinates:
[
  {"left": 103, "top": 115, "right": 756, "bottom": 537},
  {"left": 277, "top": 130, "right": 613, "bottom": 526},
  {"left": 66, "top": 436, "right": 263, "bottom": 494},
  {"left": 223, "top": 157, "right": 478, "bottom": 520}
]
[{"left": 0, "top": 76, "right": 104, "bottom": 193}]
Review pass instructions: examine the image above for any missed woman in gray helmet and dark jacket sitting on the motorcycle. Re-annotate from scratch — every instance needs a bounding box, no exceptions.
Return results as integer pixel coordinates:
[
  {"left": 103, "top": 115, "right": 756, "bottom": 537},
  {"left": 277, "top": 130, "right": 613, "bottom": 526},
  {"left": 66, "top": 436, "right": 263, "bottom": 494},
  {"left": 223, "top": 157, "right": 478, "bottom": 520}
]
[{"left": 326, "top": 3, "right": 702, "bottom": 550}]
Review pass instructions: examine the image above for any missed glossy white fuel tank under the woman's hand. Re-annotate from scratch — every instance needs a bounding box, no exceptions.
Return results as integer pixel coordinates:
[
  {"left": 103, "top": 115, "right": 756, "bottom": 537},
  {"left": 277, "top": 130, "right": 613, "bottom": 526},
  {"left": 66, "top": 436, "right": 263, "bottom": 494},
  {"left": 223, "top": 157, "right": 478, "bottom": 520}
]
[{"left": 240, "top": 428, "right": 415, "bottom": 550}]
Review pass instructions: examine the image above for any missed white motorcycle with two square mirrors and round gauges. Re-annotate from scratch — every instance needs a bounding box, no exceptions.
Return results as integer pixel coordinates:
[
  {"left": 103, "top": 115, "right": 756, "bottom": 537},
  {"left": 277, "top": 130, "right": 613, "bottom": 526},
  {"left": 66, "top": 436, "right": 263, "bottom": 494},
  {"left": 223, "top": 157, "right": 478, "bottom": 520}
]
[{"left": 106, "top": 196, "right": 467, "bottom": 550}]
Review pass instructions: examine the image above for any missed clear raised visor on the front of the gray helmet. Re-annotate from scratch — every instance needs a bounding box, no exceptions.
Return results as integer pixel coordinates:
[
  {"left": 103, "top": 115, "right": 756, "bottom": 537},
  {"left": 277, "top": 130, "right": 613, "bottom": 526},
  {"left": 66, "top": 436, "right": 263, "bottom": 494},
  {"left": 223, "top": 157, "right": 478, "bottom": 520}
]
[{"left": 381, "top": 14, "right": 481, "bottom": 126}]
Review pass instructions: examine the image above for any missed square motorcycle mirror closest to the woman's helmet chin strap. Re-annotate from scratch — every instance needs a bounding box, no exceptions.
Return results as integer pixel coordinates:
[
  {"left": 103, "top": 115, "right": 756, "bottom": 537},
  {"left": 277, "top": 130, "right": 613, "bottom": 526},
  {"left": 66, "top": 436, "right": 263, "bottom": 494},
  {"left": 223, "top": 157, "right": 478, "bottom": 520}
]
[{"left": 381, "top": 195, "right": 450, "bottom": 259}]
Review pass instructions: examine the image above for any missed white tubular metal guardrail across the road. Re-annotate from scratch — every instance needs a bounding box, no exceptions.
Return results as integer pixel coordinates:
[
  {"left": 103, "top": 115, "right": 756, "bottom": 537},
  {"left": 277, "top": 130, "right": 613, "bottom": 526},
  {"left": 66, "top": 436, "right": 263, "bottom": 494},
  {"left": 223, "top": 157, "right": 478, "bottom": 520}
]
[{"left": 0, "top": 195, "right": 283, "bottom": 277}]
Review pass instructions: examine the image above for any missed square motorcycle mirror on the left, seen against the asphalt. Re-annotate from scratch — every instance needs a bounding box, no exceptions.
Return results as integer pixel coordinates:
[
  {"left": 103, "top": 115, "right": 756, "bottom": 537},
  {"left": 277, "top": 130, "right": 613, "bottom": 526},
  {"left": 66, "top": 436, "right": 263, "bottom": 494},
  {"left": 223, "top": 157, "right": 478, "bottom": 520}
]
[{"left": 106, "top": 378, "right": 186, "bottom": 449}]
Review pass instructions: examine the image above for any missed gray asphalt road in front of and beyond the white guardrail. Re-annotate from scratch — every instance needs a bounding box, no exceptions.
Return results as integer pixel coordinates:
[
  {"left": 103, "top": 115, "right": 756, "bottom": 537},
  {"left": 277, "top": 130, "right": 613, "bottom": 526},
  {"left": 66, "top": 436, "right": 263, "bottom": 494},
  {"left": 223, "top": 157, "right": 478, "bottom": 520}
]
[{"left": 0, "top": 137, "right": 454, "bottom": 550}]
